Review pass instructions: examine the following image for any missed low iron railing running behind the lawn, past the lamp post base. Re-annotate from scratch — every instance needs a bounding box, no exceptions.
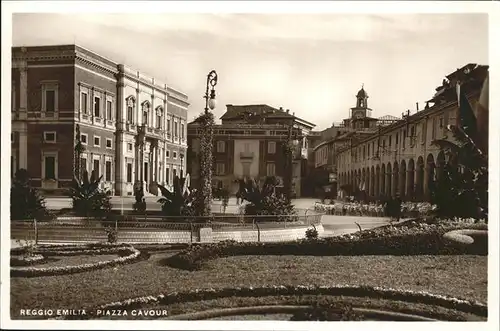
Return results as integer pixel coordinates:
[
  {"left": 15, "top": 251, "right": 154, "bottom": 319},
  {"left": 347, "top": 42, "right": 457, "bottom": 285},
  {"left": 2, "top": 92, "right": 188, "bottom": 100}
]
[{"left": 11, "top": 210, "right": 322, "bottom": 244}]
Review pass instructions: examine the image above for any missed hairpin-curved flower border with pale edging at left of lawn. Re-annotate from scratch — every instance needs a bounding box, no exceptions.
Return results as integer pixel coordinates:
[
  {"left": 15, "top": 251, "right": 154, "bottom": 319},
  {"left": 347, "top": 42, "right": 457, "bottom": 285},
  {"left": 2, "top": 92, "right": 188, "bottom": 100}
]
[{"left": 10, "top": 244, "right": 141, "bottom": 277}]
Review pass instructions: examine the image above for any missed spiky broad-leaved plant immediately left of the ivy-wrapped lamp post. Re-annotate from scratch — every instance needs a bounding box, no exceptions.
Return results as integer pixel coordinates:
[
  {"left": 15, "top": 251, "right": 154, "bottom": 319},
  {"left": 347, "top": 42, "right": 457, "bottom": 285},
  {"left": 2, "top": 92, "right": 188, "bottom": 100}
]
[{"left": 158, "top": 175, "right": 201, "bottom": 216}]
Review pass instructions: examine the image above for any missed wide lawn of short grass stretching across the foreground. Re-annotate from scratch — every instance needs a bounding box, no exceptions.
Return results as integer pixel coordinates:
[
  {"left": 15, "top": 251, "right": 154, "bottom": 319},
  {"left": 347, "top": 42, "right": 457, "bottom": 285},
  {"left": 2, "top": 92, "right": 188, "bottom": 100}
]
[{"left": 11, "top": 252, "right": 488, "bottom": 318}]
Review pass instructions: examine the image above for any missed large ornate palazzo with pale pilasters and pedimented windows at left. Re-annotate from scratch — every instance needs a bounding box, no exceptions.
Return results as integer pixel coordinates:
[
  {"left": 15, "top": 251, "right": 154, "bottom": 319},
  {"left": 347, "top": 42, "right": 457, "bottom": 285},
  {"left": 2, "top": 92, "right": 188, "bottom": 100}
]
[{"left": 11, "top": 45, "right": 189, "bottom": 195}]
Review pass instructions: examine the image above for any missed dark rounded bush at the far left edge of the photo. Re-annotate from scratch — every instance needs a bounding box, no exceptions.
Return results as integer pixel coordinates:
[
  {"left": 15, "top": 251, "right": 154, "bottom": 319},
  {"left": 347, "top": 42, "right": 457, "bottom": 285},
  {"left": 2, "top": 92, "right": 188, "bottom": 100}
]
[{"left": 10, "top": 169, "right": 50, "bottom": 220}]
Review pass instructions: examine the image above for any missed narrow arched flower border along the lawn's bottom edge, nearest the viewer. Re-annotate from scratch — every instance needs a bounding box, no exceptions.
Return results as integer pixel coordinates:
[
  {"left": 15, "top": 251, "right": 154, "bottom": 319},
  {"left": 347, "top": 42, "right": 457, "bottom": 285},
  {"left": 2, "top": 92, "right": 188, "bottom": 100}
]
[{"left": 55, "top": 285, "right": 488, "bottom": 319}]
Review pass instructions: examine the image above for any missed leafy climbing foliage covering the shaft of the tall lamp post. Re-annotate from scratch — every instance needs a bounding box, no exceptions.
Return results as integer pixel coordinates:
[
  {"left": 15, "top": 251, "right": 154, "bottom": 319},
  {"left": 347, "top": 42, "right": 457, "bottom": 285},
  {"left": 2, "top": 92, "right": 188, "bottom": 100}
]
[{"left": 195, "top": 112, "right": 215, "bottom": 216}]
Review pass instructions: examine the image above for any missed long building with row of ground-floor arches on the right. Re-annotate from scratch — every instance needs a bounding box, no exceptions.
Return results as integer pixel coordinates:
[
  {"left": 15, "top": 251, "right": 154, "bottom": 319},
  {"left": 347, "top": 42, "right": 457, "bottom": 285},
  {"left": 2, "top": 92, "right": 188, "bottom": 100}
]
[{"left": 335, "top": 64, "right": 488, "bottom": 201}]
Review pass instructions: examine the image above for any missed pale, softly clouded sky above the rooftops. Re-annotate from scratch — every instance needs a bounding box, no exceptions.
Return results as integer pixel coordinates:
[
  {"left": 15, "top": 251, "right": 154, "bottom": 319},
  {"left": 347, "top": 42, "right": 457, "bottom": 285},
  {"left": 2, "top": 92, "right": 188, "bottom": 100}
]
[{"left": 12, "top": 13, "right": 489, "bottom": 130}]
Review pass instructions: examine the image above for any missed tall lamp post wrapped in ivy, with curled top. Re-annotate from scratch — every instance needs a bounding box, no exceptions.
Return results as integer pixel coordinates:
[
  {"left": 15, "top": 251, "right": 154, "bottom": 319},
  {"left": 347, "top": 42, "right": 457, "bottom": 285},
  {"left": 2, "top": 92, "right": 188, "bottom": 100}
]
[{"left": 197, "top": 70, "right": 218, "bottom": 217}]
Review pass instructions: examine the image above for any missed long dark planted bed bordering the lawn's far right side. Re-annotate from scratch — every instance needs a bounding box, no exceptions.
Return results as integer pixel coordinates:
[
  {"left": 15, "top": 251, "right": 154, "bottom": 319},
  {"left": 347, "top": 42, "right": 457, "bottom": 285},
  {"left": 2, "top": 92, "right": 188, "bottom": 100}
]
[{"left": 167, "top": 221, "right": 488, "bottom": 270}]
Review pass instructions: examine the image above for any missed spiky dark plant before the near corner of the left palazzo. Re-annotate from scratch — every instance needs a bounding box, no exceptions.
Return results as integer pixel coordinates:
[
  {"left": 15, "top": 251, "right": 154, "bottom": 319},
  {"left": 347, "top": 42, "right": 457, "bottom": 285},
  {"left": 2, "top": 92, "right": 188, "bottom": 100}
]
[{"left": 71, "top": 171, "right": 111, "bottom": 217}]
